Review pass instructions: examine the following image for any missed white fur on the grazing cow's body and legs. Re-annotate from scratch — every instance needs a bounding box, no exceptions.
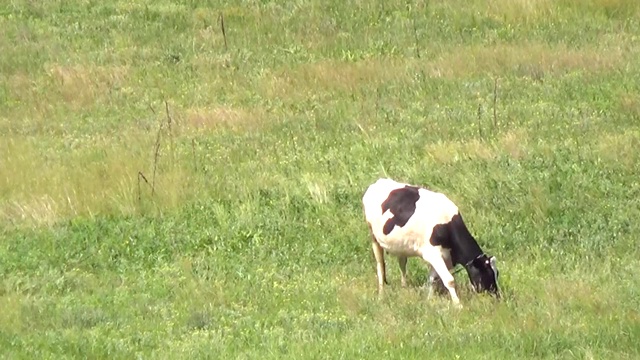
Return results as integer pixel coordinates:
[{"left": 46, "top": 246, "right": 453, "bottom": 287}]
[{"left": 362, "top": 178, "right": 460, "bottom": 305}]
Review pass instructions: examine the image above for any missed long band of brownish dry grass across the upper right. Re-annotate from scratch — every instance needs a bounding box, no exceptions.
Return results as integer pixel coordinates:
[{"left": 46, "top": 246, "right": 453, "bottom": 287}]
[{"left": 261, "top": 39, "right": 631, "bottom": 95}]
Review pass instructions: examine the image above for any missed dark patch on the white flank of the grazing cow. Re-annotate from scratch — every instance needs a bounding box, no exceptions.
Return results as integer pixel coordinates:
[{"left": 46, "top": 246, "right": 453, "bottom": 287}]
[{"left": 382, "top": 185, "right": 420, "bottom": 235}]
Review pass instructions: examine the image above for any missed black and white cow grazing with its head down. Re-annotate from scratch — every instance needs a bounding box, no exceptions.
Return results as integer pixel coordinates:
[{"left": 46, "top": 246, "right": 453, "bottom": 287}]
[{"left": 362, "top": 179, "right": 500, "bottom": 305}]
